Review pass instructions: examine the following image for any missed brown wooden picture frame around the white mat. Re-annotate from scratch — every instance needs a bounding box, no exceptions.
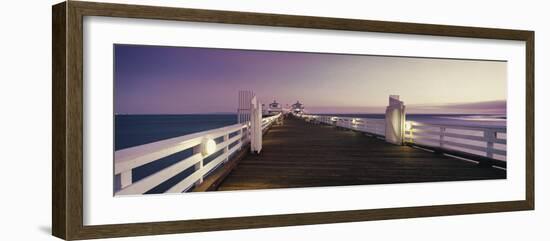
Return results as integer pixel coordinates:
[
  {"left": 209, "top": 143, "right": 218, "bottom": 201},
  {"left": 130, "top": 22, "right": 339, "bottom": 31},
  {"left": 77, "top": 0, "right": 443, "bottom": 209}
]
[{"left": 52, "top": 1, "right": 535, "bottom": 240}]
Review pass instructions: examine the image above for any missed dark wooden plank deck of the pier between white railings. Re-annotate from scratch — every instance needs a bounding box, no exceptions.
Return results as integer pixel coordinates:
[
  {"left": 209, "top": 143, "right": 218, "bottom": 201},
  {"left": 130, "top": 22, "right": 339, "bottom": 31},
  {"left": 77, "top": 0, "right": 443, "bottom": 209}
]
[{"left": 217, "top": 116, "right": 506, "bottom": 190}]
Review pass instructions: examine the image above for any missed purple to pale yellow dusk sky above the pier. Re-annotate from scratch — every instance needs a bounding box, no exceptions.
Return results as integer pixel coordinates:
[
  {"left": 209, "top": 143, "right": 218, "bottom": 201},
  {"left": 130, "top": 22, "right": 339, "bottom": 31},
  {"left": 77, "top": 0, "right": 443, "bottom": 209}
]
[{"left": 114, "top": 45, "right": 507, "bottom": 114}]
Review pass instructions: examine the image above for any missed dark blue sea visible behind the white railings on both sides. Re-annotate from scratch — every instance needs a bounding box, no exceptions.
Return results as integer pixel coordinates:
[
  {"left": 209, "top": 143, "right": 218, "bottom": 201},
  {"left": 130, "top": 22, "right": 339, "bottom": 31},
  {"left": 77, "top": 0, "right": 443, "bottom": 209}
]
[{"left": 114, "top": 112, "right": 507, "bottom": 150}]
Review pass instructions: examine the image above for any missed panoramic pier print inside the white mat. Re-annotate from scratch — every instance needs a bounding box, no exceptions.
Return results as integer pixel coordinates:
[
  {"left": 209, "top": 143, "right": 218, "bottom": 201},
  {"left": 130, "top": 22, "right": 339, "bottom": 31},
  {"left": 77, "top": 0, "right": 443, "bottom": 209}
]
[{"left": 113, "top": 44, "right": 507, "bottom": 196}]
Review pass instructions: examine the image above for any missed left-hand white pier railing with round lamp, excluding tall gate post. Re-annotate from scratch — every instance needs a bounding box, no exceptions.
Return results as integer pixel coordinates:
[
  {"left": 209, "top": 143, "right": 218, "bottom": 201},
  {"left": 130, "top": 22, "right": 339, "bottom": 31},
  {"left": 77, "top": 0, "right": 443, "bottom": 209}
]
[{"left": 114, "top": 114, "right": 281, "bottom": 195}]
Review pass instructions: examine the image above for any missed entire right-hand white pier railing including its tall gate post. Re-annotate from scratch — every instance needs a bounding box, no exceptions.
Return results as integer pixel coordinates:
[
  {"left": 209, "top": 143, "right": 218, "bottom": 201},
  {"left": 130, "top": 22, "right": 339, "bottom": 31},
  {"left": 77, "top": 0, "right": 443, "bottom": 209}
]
[{"left": 297, "top": 95, "right": 506, "bottom": 164}]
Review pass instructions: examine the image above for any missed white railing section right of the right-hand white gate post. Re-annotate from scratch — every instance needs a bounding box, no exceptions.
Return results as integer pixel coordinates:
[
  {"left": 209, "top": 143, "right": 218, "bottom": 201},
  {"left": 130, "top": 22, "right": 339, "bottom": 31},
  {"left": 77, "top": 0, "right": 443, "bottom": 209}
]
[{"left": 405, "top": 121, "right": 506, "bottom": 161}]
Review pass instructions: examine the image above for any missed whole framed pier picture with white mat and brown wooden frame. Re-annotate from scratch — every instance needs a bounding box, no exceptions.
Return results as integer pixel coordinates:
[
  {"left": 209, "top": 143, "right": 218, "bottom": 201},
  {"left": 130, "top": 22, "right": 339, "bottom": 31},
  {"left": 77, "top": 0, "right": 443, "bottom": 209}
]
[{"left": 52, "top": 1, "right": 534, "bottom": 240}]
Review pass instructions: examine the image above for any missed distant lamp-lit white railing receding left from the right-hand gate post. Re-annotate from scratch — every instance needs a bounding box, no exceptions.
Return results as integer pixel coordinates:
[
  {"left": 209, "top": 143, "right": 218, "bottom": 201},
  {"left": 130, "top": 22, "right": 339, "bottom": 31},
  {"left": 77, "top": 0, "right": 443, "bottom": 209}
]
[{"left": 301, "top": 114, "right": 386, "bottom": 136}]
